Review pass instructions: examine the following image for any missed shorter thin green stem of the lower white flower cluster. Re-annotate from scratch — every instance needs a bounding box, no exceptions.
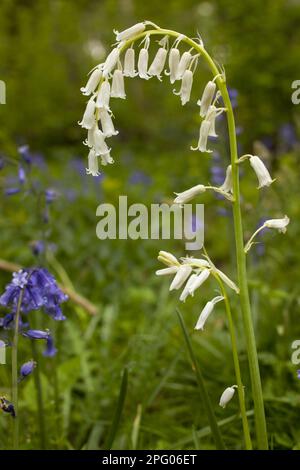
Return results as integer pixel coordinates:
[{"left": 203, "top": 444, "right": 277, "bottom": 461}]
[{"left": 214, "top": 274, "right": 252, "bottom": 450}]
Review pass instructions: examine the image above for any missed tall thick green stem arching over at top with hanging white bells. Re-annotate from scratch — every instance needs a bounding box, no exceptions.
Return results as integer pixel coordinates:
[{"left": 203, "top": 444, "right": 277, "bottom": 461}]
[{"left": 120, "top": 28, "right": 268, "bottom": 450}]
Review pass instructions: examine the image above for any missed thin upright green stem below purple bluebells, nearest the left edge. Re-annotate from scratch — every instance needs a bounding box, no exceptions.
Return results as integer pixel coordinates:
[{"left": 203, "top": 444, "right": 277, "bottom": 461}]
[{"left": 11, "top": 289, "right": 24, "bottom": 450}]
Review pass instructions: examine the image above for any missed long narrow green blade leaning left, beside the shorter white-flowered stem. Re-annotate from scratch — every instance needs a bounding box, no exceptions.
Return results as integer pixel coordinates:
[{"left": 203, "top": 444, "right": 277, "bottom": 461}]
[{"left": 176, "top": 309, "right": 225, "bottom": 450}]
